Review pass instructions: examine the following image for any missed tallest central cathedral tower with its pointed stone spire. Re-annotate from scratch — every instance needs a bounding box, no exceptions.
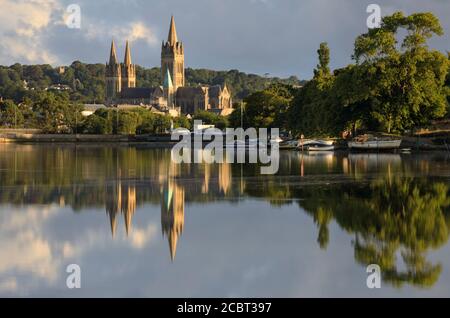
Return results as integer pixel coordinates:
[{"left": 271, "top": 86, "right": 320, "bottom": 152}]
[{"left": 161, "top": 16, "right": 185, "bottom": 91}]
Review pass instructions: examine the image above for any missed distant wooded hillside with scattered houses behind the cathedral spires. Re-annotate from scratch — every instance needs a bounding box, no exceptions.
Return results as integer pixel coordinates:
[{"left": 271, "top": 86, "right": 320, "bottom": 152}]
[{"left": 0, "top": 61, "right": 301, "bottom": 104}]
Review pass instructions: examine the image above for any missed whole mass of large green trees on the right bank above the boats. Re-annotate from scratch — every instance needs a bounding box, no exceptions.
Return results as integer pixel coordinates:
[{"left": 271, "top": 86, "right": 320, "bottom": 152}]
[{"left": 290, "top": 12, "right": 450, "bottom": 135}]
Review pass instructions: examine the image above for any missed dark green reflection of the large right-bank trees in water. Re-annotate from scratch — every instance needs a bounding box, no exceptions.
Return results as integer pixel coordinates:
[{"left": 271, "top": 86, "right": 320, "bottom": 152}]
[{"left": 301, "top": 177, "right": 450, "bottom": 287}]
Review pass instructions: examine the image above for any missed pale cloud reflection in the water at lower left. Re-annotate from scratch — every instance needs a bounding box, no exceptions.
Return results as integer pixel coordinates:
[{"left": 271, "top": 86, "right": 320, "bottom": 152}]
[{"left": 0, "top": 205, "right": 158, "bottom": 295}]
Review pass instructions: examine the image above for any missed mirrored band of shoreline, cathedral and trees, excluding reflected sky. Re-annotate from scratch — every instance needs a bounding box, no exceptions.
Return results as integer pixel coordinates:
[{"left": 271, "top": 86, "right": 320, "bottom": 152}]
[{"left": 0, "top": 145, "right": 450, "bottom": 294}]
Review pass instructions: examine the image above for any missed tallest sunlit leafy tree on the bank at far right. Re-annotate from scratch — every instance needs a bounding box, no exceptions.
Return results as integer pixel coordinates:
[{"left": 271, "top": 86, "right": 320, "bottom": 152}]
[{"left": 350, "top": 12, "right": 450, "bottom": 132}]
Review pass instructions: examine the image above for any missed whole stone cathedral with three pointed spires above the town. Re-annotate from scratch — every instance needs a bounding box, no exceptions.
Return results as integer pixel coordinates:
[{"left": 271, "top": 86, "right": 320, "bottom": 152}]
[{"left": 106, "top": 16, "right": 233, "bottom": 117}]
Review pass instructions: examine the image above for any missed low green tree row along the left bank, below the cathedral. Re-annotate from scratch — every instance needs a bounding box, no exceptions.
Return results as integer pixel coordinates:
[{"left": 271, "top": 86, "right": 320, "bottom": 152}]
[{"left": 0, "top": 91, "right": 229, "bottom": 135}]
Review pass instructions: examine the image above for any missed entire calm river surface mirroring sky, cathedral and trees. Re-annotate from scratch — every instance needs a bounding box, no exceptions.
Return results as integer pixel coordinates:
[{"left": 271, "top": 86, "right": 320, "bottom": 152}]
[{"left": 0, "top": 145, "right": 450, "bottom": 297}]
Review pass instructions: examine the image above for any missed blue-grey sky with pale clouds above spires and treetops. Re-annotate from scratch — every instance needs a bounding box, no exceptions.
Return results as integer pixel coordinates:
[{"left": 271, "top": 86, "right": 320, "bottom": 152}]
[{"left": 0, "top": 0, "right": 450, "bottom": 79}]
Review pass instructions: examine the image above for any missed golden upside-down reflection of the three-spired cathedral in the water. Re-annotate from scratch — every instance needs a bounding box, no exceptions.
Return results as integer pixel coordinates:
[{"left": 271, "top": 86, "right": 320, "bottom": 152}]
[{"left": 105, "top": 154, "right": 236, "bottom": 261}]
